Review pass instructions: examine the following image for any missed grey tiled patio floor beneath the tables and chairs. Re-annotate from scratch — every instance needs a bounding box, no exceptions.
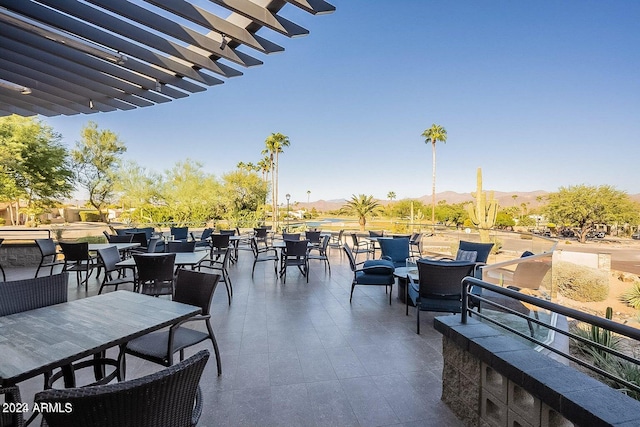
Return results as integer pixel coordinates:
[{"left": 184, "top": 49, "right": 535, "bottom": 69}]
[{"left": 2, "top": 247, "right": 462, "bottom": 426}]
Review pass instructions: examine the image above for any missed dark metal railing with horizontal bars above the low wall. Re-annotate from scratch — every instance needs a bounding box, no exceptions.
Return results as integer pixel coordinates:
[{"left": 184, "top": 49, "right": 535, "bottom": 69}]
[{"left": 462, "top": 277, "right": 640, "bottom": 394}]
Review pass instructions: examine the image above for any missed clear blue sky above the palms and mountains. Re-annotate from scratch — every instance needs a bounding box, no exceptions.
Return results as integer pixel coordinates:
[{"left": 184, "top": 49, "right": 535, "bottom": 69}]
[{"left": 43, "top": 0, "right": 640, "bottom": 206}]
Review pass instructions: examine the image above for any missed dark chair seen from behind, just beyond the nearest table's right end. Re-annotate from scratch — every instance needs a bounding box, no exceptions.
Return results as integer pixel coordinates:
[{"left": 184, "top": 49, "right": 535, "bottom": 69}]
[{"left": 133, "top": 253, "right": 176, "bottom": 296}]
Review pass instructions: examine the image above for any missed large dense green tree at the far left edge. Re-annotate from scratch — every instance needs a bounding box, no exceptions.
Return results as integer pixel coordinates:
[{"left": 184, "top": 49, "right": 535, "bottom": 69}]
[{"left": 0, "top": 115, "right": 73, "bottom": 224}]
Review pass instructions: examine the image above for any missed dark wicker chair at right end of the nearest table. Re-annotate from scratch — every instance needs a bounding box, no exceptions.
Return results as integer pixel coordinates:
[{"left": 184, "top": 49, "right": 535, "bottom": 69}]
[{"left": 122, "top": 270, "right": 222, "bottom": 378}]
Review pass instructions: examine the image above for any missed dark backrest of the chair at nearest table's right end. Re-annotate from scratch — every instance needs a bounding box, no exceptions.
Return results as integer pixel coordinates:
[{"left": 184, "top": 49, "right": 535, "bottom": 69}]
[{"left": 173, "top": 268, "right": 220, "bottom": 315}]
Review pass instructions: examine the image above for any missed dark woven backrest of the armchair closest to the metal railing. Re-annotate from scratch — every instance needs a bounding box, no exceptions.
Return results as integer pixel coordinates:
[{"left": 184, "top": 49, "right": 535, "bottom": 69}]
[{"left": 417, "top": 259, "right": 476, "bottom": 299}]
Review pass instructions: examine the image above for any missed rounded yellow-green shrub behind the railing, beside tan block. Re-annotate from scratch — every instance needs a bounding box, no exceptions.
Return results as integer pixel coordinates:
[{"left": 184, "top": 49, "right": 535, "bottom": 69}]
[{"left": 553, "top": 261, "right": 609, "bottom": 302}]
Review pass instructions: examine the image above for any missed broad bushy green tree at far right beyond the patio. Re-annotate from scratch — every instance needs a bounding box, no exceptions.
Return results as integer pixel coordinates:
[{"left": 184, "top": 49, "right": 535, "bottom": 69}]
[{"left": 544, "top": 185, "right": 639, "bottom": 243}]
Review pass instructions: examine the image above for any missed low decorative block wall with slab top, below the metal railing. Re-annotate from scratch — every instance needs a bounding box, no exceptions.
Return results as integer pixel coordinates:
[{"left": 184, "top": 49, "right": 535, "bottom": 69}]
[{"left": 434, "top": 316, "right": 640, "bottom": 427}]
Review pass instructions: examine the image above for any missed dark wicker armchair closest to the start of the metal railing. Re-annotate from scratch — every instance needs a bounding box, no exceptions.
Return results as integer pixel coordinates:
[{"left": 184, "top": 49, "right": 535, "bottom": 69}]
[{"left": 407, "top": 259, "right": 476, "bottom": 334}]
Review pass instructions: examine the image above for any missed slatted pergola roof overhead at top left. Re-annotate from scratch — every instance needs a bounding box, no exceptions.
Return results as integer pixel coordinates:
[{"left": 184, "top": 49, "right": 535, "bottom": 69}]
[{"left": 0, "top": 0, "right": 335, "bottom": 116}]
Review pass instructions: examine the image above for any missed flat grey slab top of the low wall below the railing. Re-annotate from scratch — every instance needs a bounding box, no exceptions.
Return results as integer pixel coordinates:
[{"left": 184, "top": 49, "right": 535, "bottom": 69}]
[{"left": 434, "top": 315, "right": 640, "bottom": 426}]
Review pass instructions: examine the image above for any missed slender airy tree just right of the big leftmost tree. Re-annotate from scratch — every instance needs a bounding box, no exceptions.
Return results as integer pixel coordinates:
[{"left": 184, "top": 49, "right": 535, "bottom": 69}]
[{"left": 71, "top": 121, "right": 127, "bottom": 221}]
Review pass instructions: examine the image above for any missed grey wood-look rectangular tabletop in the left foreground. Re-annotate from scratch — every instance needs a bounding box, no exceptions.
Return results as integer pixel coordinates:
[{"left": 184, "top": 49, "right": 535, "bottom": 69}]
[{"left": 0, "top": 291, "right": 200, "bottom": 386}]
